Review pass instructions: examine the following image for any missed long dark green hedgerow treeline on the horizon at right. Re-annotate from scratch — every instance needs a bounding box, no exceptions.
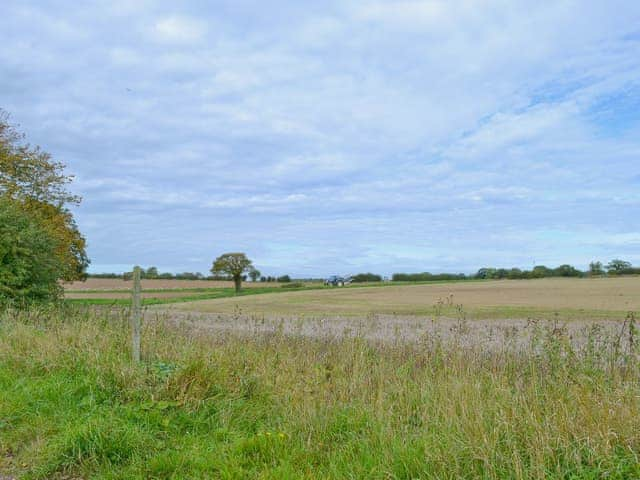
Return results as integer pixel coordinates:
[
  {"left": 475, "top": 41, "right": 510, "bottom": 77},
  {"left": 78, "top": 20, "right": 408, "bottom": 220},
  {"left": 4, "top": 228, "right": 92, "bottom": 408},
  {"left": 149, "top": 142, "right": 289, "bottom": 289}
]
[{"left": 391, "top": 259, "right": 640, "bottom": 282}]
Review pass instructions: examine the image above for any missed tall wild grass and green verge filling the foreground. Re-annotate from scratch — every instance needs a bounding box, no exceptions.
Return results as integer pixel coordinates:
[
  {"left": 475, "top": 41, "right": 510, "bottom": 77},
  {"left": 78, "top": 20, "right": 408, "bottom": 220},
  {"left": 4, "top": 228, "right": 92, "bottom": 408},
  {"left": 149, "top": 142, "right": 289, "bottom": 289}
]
[{"left": 0, "top": 309, "right": 640, "bottom": 479}]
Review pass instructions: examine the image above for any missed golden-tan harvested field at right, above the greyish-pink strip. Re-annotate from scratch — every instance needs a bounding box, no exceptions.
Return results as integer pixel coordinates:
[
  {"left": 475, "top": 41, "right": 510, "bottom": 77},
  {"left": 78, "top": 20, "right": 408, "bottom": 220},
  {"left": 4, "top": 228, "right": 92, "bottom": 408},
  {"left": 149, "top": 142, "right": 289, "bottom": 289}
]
[{"left": 165, "top": 277, "right": 640, "bottom": 320}]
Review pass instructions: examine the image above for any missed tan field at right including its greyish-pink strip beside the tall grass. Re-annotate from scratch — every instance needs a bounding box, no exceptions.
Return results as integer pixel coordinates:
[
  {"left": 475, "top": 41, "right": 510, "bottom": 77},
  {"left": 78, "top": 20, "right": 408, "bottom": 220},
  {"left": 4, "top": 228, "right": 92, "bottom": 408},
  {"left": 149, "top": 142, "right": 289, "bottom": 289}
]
[{"left": 147, "top": 277, "right": 640, "bottom": 349}]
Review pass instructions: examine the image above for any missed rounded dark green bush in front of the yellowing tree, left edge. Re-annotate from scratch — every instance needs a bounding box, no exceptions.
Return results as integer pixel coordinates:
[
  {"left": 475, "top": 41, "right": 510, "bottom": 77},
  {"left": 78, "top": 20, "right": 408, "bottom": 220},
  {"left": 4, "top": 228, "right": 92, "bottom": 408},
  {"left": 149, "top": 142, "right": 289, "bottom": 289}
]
[{"left": 0, "top": 198, "right": 65, "bottom": 304}]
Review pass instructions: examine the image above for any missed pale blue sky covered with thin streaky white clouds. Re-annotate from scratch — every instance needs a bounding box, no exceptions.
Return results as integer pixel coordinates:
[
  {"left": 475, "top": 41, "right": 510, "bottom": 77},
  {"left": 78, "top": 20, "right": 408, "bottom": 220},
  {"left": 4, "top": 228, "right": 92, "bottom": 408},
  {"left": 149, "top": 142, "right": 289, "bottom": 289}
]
[{"left": 0, "top": 0, "right": 640, "bottom": 277}]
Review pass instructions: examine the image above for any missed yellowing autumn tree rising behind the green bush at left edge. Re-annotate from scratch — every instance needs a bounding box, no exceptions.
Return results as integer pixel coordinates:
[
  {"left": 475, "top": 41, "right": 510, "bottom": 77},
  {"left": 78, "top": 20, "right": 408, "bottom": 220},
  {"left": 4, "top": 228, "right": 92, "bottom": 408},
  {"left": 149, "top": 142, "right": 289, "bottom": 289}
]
[{"left": 0, "top": 110, "right": 89, "bottom": 281}]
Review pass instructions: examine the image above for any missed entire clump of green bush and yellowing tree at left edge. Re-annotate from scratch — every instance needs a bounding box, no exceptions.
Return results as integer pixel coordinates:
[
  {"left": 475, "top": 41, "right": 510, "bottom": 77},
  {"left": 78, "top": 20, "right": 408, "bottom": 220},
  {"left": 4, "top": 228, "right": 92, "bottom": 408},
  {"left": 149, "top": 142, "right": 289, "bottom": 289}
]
[{"left": 0, "top": 110, "right": 89, "bottom": 301}]
